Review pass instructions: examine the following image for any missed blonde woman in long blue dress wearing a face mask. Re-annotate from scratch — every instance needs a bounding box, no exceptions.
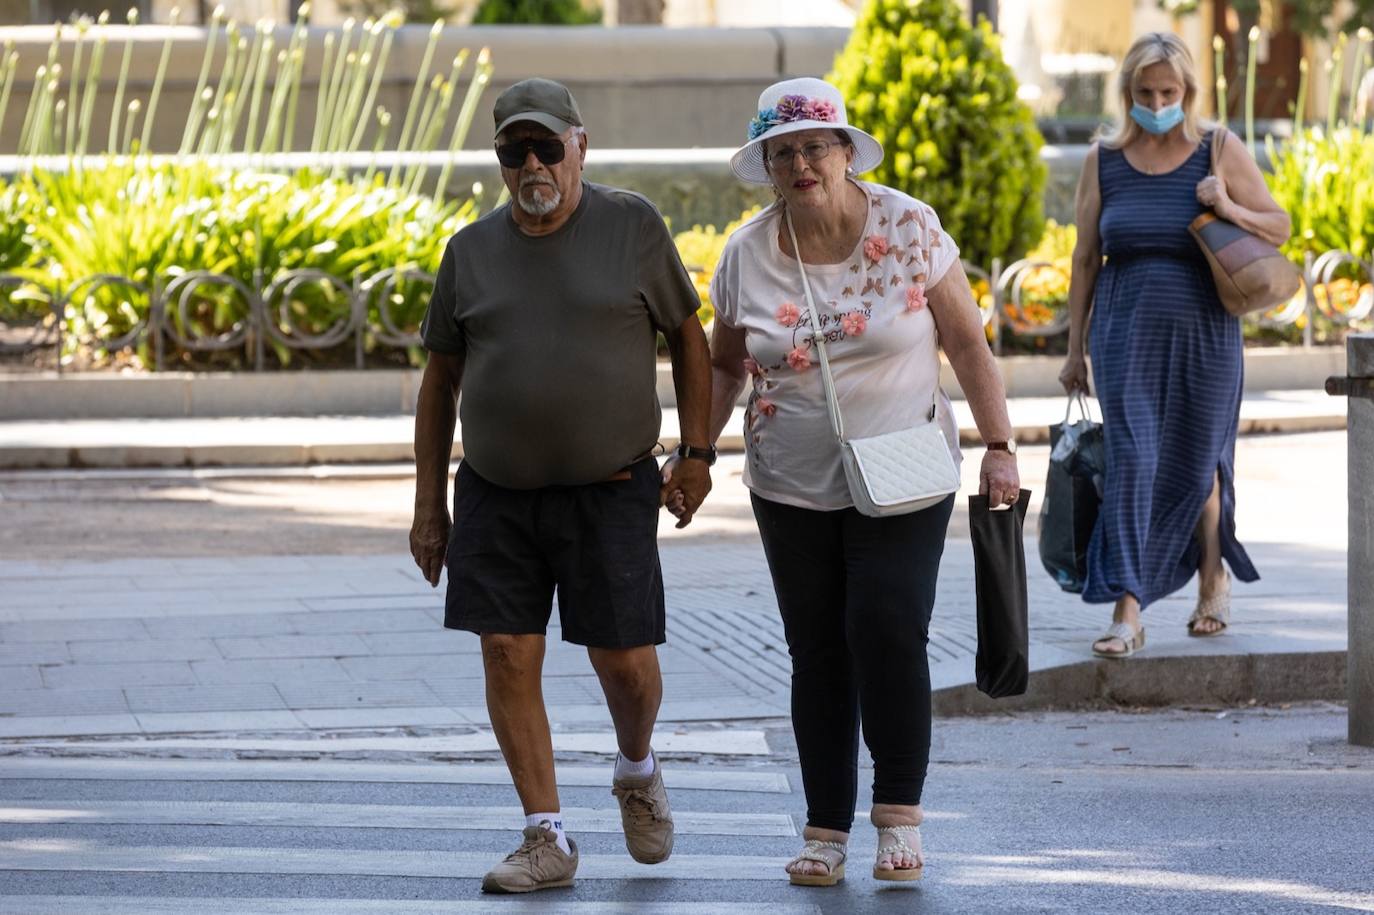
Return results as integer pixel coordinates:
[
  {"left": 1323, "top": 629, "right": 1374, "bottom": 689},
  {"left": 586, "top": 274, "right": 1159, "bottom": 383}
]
[{"left": 1059, "top": 32, "right": 1289, "bottom": 658}]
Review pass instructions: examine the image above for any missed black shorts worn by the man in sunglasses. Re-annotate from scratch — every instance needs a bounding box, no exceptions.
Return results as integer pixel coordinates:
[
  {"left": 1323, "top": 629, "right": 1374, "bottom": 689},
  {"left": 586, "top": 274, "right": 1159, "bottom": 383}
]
[{"left": 444, "top": 458, "right": 664, "bottom": 648}]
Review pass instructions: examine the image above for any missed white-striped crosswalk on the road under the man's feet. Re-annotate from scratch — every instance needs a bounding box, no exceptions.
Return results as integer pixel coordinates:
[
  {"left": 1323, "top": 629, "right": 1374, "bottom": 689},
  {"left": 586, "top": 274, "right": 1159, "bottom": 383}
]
[{"left": 0, "top": 731, "right": 802, "bottom": 915}]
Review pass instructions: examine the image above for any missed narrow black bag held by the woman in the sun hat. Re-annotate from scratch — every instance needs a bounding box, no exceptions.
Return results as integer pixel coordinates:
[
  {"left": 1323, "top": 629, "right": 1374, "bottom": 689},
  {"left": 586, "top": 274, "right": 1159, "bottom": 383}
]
[{"left": 969, "top": 489, "right": 1031, "bottom": 699}]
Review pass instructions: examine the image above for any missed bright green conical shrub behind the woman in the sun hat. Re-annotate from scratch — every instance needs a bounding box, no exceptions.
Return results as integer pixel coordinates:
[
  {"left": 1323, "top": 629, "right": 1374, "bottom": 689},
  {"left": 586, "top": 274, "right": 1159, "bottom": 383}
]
[{"left": 830, "top": 0, "right": 1047, "bottom": 264}]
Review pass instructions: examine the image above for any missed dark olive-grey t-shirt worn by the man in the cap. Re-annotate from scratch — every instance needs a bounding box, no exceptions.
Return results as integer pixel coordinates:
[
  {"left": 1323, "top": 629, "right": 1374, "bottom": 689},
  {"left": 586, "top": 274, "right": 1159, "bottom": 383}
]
[{"left": 420, "top": 183, "right": 699, "bottom": 489}]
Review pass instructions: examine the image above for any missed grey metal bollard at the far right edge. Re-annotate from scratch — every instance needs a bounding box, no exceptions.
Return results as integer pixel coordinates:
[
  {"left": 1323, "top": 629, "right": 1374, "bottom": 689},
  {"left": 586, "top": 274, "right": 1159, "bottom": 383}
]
[{"left": 1326, "top": 334, "right": 1374, "bottom": 746}]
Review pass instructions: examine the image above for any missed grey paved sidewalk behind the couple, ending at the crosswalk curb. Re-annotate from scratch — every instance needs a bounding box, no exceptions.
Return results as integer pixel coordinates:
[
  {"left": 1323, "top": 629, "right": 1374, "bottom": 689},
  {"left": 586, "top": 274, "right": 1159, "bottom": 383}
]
[{"left": 0, "top": 433, "right": 1347, "bottom": 739}]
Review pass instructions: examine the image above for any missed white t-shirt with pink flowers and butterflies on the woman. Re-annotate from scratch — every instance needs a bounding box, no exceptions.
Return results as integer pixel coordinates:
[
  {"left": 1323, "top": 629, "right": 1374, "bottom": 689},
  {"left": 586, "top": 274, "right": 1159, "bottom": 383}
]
[{"left": 710, "top": 181, "right": 960, "bottom": 510}]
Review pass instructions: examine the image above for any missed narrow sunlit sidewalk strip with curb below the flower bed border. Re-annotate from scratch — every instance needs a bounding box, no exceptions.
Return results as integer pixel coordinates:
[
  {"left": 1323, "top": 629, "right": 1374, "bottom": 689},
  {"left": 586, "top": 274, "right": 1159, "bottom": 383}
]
[{"left": 0, "top": 390, "right": 1345, "bottom": 468}]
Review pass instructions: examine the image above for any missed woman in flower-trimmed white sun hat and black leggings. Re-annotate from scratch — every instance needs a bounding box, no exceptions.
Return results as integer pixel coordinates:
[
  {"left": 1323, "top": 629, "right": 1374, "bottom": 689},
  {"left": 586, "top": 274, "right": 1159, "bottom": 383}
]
[{"left": 670, "top": 78, "right": 1020, "bottom": 886}]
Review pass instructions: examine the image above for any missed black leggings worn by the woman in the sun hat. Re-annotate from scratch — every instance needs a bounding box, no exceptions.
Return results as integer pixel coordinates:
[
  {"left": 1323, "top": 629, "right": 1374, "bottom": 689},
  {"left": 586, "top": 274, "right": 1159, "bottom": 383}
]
[{"left": 752, "top": 496, "right": 954, "bottom": 833}]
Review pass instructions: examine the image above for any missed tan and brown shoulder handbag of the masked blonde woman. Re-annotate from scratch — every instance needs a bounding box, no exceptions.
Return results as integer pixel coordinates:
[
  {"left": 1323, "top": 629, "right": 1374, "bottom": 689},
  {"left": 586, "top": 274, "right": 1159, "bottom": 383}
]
[{"left": 1189, "top": 128, "right": 1303, "bottom": 317}]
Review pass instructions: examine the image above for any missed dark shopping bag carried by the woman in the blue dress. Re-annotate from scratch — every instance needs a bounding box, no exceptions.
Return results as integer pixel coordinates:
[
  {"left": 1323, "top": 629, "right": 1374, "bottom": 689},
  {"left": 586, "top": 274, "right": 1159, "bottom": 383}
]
[{"left": 1039, "top": 392, "right": 1107, "bottom": 594}]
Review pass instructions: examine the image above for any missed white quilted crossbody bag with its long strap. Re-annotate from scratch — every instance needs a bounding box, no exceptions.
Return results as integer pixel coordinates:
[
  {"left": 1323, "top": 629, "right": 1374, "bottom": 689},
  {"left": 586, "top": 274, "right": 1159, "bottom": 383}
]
[{"left": 783, "top": 210, "right": 959, "bottom": 518}]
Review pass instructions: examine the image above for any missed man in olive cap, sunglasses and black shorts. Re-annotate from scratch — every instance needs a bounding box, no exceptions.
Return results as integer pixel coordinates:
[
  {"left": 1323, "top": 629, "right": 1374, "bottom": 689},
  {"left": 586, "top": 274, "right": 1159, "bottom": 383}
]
[{"left": 411, "top": 80, "right": 714, "bottom": 893}]
